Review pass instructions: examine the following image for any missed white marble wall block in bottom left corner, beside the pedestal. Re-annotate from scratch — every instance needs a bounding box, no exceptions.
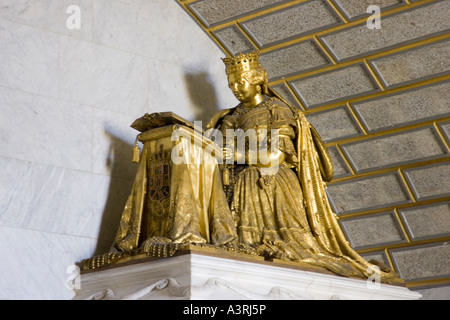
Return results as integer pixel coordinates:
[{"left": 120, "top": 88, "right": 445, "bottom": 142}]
[{"left": 0, "top": 227, "right": 97, "bottom": 300}]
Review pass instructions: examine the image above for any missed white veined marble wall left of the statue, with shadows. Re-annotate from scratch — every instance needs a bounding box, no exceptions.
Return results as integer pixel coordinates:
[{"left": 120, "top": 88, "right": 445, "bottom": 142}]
[{"left": 0, "top": 0, "right": 235, "bottom": 299}]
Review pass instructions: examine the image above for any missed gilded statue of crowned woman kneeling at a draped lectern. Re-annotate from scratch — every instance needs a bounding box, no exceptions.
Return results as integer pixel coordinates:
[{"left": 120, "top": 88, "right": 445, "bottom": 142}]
[{"left": 81, "top": 52, "right": 397, "bottom": 282}]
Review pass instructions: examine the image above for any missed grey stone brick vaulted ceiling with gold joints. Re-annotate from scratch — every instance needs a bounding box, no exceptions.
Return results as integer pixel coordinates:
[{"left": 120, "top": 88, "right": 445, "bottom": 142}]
[{"left": 176, "top": 0, "right": 450, "bottom": 288}]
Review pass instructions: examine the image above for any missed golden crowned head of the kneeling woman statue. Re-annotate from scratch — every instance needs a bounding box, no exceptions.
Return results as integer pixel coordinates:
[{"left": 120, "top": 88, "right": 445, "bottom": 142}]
[{"left": 222, "top": 52, "right": 268, "bottom": 102}]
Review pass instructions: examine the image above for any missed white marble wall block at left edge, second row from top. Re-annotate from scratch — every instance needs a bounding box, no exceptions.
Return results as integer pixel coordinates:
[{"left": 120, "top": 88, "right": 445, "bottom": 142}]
[{"left": 0, "top": 19, "right": 58, "bottom": 97}]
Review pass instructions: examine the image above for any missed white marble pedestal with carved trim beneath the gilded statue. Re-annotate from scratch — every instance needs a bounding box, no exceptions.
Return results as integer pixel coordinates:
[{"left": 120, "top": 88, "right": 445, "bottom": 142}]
[{"left": 74, "top": 251, "right": 421, "bottom": 300}]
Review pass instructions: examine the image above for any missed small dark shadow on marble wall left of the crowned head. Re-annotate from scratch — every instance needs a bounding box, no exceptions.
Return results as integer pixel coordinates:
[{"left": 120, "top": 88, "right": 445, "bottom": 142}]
[{"left": 184, "top": 72, "right": 218, "bottom": 126}]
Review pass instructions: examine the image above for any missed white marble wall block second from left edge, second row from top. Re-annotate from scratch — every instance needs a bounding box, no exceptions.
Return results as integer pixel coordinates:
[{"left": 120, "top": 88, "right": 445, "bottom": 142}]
[{"left": 59, "top": 36, "right": 148, "bottom": 115}]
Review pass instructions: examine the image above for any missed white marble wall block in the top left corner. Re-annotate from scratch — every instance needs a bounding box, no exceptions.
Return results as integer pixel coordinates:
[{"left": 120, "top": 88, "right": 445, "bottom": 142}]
[{"left": 0, "top": 0, "right": 93, "bottom": 40}]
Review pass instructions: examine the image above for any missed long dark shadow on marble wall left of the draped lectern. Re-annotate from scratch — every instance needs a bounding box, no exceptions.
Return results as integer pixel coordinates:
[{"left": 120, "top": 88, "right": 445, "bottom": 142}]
[{"left": 94, "top": 132, "right": 138, "bottom": 255}]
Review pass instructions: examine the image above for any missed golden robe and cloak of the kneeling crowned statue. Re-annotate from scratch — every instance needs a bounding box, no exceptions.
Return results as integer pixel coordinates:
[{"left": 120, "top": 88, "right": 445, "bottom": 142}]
[{"left": 207, "top": 98, "right": 395, "bottom": 282}]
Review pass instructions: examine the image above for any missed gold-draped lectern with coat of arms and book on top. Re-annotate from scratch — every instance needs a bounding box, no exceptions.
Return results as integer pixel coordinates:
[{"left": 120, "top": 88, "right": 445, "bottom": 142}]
[{"left": 82, "top": 112, "right": 243, "bottom": 270}]
